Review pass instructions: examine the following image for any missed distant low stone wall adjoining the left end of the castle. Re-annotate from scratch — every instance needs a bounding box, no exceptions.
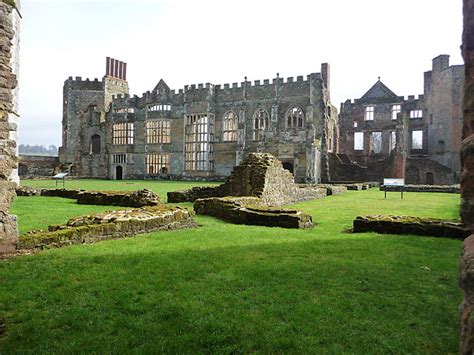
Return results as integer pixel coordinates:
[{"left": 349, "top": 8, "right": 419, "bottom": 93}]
[{"left": 18, "top": 155, "right": 60, "bottom": 179}]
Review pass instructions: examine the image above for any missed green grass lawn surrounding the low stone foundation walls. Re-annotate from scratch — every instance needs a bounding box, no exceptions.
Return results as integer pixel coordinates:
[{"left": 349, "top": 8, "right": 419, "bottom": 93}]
[{"left": 0, "top": 180, "right": 462, "bottom": 354}]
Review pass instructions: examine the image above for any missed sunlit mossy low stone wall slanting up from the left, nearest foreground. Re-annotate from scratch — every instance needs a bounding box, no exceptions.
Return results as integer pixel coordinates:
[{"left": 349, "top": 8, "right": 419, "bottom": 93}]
[{"left": 18, "top": 206, "right": 197, "bottom": 249}]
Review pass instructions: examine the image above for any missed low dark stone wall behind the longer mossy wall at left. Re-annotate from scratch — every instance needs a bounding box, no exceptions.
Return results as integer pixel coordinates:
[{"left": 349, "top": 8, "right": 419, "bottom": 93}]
[{"left": 16, "top": 186, "right": 162, "bottom": 208}]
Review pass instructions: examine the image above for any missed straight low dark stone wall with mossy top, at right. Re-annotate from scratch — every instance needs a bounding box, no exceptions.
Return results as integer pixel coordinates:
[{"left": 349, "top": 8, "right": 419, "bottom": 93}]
[{"left": 353, "top": 215, "right": 470, "bottom": 240}]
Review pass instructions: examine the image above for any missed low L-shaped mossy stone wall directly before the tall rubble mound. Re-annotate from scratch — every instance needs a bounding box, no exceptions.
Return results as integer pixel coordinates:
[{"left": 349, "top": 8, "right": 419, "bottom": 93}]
[{"left": 194, "top": 197, "right": 313, "bottom": 228}]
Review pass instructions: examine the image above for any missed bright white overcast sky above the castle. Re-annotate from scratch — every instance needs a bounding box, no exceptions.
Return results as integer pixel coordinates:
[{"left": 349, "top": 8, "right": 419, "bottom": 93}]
[{"left": 20, "top": 0, "right": 462, "bottom": 146}]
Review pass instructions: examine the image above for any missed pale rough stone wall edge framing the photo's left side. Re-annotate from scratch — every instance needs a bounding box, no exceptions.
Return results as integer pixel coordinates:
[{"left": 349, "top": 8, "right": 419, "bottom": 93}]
[{"left": 0, "top": 1, "right": 19, "bottom": 254}]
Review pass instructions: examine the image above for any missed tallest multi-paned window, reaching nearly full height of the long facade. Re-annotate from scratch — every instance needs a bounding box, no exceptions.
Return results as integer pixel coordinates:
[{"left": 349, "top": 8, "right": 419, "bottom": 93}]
[{"left": 184, "top": 114, "right": 214, "bottom": 171}]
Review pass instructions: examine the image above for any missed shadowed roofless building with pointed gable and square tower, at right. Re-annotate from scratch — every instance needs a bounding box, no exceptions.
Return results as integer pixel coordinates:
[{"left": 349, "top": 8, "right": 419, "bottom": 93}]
[{"left": 336, "top": 55, "right": 464, "bottom": 184}]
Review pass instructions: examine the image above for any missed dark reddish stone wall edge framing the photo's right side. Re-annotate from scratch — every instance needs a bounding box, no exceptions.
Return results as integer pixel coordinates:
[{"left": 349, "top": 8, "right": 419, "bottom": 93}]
[{"left": 460, "top": 0, "right": 474, "bottom": 354}]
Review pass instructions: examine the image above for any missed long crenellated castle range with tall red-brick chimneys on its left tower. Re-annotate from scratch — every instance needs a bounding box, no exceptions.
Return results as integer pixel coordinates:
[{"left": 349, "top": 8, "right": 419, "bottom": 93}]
[{"left": 60, "top": 58, "right": 337, "bottom": 182}]
